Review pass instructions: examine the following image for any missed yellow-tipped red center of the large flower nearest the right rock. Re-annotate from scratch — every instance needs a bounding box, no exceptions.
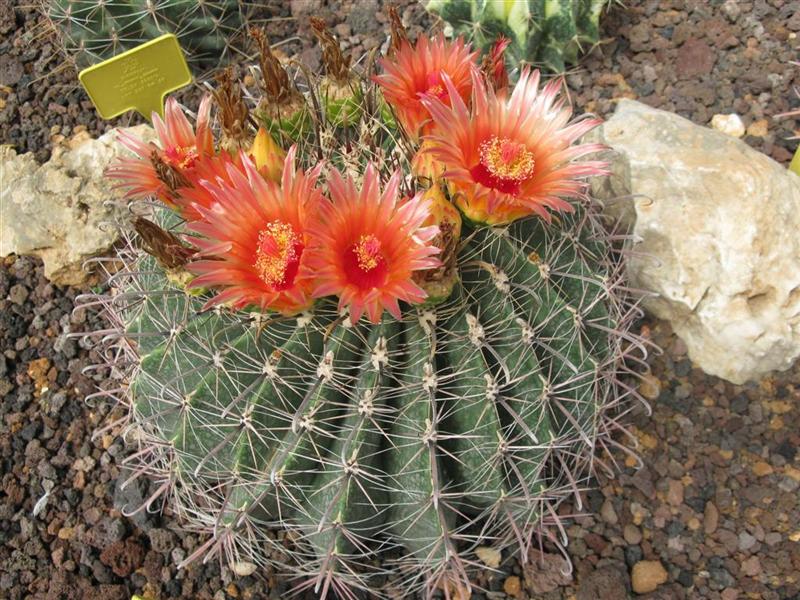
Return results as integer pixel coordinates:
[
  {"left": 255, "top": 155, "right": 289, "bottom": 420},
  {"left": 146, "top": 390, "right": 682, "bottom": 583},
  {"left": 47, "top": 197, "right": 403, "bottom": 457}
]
[{"left": 471, "top": 136, "right": 534, "bottom": 194}]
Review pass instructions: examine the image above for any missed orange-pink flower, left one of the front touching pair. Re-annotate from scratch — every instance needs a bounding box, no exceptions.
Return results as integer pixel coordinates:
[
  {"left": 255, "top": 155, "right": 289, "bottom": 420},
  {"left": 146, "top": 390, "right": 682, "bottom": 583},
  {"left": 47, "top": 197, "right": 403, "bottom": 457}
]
[{"left": 187, "top": 147, "right": 322, "bottom": 314}]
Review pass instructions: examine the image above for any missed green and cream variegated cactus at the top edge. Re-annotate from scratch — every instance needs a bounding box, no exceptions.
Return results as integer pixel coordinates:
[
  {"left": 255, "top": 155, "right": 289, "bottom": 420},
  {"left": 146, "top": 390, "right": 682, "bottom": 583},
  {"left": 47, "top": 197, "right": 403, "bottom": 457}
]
[{"left": 426, "top": 0, "right": 609, "bottom": 73}]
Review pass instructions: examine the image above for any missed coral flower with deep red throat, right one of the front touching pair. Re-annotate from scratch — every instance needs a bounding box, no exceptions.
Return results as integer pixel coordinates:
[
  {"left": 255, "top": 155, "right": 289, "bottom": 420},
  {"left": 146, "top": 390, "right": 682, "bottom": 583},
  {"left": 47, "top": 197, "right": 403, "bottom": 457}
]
[{"left": 307, "top": 164, "right": 440, "bottom": 323}]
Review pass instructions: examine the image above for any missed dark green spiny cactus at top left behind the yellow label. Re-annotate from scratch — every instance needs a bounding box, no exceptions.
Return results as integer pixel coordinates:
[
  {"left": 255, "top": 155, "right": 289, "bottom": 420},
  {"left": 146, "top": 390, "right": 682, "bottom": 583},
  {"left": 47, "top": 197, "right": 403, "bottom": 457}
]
[{"left": 44, "top": 0, "right": 245, "bottom": 71}]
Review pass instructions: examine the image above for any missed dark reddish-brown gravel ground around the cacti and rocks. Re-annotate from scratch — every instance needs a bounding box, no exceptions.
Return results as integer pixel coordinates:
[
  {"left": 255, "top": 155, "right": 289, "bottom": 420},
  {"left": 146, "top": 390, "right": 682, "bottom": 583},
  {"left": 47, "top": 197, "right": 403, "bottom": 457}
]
[{"left": 0, "top": 0, "right": 800, "bottom": 600}]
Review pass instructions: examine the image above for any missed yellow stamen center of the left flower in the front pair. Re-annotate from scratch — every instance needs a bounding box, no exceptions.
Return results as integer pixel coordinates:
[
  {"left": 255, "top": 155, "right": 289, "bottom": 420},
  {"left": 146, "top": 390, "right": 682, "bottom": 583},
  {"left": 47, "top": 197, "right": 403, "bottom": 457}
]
[{"left": 253, "top": 221, "right": 305, "bottom": 292}]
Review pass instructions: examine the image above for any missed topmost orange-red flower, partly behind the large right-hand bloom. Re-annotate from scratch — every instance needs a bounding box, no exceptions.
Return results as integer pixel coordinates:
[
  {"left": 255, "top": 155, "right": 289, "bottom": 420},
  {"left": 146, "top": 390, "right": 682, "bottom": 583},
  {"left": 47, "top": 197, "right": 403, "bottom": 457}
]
[{"left": 374, "top": 35, "right": 477, "bottom": 140}]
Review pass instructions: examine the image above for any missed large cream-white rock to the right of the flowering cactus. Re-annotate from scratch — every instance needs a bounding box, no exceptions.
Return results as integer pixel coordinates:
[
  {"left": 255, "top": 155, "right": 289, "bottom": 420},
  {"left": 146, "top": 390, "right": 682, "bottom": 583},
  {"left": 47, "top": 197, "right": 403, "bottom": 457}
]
[{"left": 592, "top": 100, "right": 800, "bottom": 383}]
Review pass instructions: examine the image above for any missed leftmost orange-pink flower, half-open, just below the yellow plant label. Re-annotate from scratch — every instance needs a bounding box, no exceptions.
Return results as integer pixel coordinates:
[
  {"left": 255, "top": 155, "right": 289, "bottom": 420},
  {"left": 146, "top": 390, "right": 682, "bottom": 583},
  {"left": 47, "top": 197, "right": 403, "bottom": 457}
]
[{"left": 107, "top": 95, "right": 214, "bottom": 208}]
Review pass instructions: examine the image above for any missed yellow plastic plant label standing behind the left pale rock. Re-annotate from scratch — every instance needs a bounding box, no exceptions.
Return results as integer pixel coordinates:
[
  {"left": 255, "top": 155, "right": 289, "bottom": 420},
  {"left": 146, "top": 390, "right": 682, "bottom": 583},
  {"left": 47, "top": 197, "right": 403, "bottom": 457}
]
[{"left": 78, "top": 33, "right": 192, "bottom": 119}]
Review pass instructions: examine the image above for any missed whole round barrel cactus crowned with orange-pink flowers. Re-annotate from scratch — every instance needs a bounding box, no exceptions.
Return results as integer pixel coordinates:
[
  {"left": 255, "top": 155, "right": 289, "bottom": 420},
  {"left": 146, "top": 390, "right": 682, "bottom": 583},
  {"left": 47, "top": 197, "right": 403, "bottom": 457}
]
[{"left": 88, "top": 19, "right": 642, "bottom": 597}]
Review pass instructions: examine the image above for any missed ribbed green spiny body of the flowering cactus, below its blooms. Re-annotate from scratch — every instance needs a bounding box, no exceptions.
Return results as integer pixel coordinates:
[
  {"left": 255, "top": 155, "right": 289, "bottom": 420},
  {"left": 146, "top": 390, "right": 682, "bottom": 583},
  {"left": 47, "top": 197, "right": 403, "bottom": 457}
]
[{"left": 111, "top": 200, "right": 623, "bottom": 592}]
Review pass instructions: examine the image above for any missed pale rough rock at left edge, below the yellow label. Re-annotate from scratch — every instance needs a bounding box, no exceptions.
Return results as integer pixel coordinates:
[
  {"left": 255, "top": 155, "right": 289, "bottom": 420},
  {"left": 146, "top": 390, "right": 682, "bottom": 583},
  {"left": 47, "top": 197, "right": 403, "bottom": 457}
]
[{"left": 0, "top": 125, "right": 155, "bottom": 285}]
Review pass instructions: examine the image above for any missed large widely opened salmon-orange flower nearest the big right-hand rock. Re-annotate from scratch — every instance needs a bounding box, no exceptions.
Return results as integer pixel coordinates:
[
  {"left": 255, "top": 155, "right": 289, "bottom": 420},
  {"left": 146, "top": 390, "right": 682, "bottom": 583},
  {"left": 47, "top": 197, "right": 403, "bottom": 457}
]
[{"left": 422, "top": 68, "right": 606, "bottom": 224}]
